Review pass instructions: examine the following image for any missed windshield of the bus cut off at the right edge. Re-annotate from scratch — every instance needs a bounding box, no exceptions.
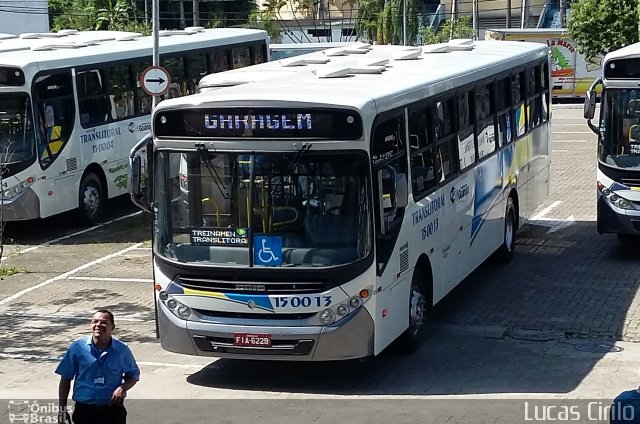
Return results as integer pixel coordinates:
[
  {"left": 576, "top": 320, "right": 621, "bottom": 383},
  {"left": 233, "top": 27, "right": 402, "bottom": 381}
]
[{"left": 598, "top": 88, "right": 640, "bottom": 168}]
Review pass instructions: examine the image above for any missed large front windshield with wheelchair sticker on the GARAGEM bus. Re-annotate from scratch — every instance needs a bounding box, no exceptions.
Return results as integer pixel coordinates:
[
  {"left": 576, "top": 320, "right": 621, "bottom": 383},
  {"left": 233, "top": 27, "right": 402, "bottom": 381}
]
[{"left": 155, "top": 150, "right": 372, "bottom": 267}]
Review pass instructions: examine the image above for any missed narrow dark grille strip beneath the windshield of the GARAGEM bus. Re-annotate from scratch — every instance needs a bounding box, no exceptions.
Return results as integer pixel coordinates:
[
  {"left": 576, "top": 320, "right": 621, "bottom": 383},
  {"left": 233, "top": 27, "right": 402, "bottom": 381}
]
[{"left": 175, "top": 276, "right": 335, "bottom": 294}]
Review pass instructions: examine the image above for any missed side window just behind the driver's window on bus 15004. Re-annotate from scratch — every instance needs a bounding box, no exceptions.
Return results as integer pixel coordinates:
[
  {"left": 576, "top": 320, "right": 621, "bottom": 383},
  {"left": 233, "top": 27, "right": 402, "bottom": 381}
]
[{"left": 76, "top": 69, "right": 112, "bottom": 128}]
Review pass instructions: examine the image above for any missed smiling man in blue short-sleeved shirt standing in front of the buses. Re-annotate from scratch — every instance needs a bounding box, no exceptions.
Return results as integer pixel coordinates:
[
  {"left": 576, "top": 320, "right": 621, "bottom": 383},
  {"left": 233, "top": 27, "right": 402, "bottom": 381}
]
[{"left": 56, "top": 309, "right": 140, "bottom": 424}]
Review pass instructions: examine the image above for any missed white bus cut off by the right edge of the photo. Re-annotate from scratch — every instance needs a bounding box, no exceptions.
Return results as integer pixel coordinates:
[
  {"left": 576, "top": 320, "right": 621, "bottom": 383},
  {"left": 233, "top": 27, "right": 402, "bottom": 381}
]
[{"left": 584, "top": 43, "right": 640, "bottom": 240}]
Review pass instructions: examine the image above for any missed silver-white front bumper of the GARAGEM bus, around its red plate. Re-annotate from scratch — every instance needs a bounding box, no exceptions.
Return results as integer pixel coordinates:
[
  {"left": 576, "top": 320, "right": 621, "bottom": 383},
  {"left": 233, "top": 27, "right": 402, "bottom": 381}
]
[{"left": 157, "top": 302, "right": 373, "bottom": 361}]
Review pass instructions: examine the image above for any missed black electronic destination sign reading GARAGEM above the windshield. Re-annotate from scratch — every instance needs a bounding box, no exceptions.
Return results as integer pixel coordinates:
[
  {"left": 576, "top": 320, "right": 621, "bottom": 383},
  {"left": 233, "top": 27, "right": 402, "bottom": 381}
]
[{"left": 154, "top": 108, "right": 362, "bottom": 140}]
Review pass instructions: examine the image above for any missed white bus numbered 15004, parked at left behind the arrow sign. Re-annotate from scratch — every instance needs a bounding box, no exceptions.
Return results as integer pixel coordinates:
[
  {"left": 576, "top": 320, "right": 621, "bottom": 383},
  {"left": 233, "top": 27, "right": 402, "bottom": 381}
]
[{"left": 0, "top": 27, "right": 268, "bottom": 224}]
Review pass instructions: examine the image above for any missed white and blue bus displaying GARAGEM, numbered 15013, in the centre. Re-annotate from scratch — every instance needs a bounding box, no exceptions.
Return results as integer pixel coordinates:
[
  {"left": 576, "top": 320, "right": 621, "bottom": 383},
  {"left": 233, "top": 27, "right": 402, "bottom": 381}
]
[{"left": 131, "top": 41, "right": 550, "bottom": 360}]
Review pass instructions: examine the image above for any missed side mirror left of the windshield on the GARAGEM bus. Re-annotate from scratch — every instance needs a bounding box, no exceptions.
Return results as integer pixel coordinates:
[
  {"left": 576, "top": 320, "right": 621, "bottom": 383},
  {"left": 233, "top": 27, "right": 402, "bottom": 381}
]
[{"left": 129, "top": 134, "right": 153, "bottom": 212}]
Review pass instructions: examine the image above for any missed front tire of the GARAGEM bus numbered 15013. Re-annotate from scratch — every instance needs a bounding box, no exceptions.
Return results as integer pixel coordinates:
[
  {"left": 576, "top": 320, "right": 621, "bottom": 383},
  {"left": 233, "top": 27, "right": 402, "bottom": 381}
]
[{"left": 398, "top": 268, "right": 431, "bottom": 354}]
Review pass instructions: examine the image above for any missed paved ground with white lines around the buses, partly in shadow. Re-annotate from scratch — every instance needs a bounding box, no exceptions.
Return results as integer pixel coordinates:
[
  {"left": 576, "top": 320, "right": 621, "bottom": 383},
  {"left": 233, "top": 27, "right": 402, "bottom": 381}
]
[{"left": 0, "top": 107, "right": 640, "bottom": 422}]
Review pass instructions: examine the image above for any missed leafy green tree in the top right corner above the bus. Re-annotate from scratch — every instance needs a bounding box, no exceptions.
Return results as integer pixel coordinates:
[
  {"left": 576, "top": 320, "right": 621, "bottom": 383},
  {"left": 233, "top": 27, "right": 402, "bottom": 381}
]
[{"left": 567, "top": 0, "right": 639, "bottom": 59}]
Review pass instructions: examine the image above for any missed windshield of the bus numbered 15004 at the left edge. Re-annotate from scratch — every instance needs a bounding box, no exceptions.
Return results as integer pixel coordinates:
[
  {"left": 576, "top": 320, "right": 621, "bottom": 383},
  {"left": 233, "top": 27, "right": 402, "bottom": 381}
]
[{"left": 0, "top": 93, "right": 35, "bottom": 169}]
